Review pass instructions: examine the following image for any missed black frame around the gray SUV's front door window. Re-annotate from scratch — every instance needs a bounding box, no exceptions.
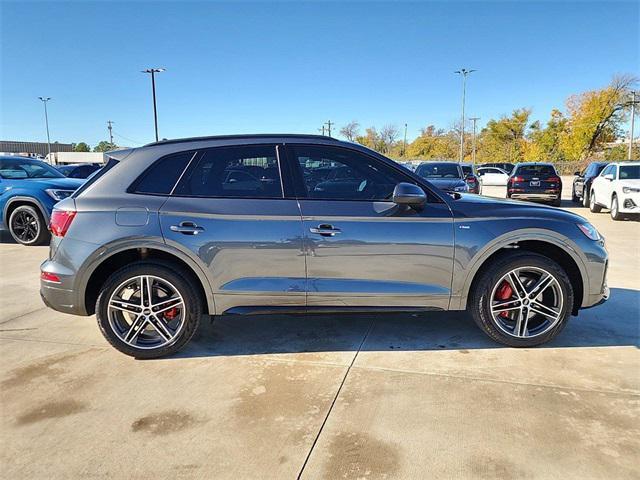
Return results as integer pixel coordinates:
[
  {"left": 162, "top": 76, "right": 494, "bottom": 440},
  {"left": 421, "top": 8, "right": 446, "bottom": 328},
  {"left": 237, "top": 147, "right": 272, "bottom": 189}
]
[{"left": 284, "top": 143, "right": 447, "bottom": 204}]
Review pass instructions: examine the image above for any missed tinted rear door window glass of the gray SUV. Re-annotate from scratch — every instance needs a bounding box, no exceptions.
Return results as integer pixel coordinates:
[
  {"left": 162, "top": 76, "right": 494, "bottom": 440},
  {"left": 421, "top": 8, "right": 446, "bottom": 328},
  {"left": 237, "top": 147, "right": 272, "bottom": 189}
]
[{"left": 175, "top": 145, "right": 283, "bottom": 198}]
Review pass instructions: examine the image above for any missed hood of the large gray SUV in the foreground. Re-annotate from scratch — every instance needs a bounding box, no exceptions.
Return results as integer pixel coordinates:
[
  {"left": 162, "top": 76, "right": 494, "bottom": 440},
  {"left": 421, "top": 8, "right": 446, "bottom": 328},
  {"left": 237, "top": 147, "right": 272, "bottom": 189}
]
[{"left": 449, "top": 193, "right": 587, "bottom": 223}]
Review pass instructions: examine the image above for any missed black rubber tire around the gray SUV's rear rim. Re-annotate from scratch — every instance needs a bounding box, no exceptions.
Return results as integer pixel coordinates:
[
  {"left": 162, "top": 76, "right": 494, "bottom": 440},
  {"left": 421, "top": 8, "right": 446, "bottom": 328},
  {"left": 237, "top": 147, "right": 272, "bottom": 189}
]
[{"left": 96, "top": 260, "right": 203, "bottom": 359}]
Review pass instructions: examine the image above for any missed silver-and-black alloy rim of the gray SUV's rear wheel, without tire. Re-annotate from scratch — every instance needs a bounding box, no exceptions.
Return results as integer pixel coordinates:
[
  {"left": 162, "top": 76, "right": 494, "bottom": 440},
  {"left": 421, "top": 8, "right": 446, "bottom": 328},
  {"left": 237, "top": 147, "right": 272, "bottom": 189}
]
[{"left": 107, "top": 275, "right": 187, "bottom": 350}]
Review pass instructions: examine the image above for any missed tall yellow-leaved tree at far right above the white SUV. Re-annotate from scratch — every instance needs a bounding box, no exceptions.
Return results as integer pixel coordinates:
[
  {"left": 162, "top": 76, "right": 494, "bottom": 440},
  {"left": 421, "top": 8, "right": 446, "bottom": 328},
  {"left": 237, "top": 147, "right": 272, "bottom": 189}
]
[{"left": 560, "top": 75, "right": 638, "bottom": 160}]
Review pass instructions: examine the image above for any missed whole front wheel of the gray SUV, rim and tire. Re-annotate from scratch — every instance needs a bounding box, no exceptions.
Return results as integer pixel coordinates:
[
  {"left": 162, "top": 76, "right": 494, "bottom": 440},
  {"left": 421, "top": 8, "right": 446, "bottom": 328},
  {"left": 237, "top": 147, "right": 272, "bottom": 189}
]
[{"left": 469, "top": 252, "right": 573, "bottom": 347}]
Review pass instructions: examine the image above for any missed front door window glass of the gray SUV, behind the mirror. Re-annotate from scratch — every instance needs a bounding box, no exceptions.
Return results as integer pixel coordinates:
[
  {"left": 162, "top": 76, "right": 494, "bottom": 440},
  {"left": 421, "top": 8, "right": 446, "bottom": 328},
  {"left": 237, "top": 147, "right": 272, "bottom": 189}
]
[{"left": 292, "top": 146, "right": 410, "bottom": 201}]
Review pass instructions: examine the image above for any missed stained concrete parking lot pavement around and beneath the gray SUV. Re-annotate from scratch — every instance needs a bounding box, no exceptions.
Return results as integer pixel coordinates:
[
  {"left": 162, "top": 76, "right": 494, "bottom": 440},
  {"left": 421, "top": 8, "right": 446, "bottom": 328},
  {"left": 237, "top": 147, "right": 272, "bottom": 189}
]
[{"left": 0, "top": 181, "right": 640, "bottom": 479}]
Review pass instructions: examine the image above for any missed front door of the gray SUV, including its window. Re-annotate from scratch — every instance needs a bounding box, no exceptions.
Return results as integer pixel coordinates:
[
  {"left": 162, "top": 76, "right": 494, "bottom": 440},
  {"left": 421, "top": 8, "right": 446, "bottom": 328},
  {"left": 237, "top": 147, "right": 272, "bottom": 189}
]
[{"left": 289, "top": 145, "right": 454, "bottom": 309}]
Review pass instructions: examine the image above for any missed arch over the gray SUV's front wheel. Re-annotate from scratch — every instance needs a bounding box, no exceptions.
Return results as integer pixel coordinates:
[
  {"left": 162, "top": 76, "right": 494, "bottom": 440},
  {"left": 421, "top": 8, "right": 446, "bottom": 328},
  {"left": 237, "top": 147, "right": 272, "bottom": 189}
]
[{"left": 460, "top": 234, "right": 589, "bottom": 315}]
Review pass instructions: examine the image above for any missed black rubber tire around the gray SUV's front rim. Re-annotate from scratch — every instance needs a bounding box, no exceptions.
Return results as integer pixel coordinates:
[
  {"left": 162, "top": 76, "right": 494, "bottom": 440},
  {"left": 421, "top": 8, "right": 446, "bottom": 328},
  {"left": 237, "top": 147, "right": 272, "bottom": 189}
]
[{"left": 468, "top": 252, "right": 573, "bottom": 347}]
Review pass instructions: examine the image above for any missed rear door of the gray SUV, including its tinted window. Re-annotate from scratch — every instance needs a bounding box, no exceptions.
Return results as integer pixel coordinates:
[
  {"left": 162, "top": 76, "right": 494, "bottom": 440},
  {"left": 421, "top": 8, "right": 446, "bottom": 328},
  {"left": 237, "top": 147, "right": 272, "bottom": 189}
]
[{"left": 160, "top": 145, "right": 305, "bottom": 313}]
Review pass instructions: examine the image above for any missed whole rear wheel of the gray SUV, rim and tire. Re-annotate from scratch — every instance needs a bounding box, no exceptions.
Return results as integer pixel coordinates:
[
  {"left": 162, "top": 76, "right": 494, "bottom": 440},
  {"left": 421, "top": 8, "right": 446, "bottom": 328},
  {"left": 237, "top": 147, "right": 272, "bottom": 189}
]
[{"left": 96, "top": 261, "right": 202, "bottom": 358}]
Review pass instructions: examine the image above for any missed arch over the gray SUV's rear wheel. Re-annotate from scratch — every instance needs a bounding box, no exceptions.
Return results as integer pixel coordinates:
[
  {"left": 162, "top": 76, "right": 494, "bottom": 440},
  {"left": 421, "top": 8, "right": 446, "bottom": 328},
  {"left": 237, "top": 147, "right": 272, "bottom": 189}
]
[{"left": 78, "top": 241, "right": 215, "bottom": 315}]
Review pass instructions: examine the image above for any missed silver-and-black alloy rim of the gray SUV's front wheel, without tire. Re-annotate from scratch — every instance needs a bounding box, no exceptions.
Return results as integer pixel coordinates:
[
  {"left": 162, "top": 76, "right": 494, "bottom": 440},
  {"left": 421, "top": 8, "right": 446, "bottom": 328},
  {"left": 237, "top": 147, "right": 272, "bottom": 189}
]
[{"left": 489, "top": 267, "right": 564, "bottom": 338}]
